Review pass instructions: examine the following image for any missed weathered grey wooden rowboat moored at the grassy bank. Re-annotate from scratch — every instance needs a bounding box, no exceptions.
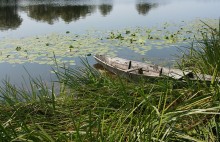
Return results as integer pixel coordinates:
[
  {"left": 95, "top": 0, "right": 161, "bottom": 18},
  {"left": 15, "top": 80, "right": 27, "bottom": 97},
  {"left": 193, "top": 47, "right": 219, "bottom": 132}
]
[{"left": 94, "top": 55, "right": 215, "bottom": 81}]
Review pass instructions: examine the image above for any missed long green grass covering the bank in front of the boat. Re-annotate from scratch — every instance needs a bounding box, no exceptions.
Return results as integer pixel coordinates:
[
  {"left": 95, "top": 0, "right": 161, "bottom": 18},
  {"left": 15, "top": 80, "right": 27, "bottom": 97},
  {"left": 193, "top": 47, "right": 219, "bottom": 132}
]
[{"left": 0, "top": 20, "right": 220, "bottom": 142}]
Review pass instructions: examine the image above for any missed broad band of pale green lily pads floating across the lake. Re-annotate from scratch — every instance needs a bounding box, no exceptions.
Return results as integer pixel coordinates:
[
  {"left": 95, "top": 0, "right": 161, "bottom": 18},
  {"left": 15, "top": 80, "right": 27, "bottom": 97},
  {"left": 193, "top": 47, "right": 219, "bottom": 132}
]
[{"left": 0, "top": 19, "right": 218, "bottom": 65}]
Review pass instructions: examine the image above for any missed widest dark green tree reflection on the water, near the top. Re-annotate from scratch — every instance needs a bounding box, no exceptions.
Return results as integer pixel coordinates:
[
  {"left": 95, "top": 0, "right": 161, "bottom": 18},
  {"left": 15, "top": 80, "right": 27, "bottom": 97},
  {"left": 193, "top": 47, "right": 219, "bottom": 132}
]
[{"left": 27, "top": 5, "right": 96, "bottom": 24}]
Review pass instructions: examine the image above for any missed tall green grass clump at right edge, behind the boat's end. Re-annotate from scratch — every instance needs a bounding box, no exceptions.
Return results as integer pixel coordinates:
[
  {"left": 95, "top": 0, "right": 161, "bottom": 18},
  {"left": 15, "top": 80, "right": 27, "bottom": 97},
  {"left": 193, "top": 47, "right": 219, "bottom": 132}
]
[{"left": 182, "top": 22, "right": 220, "bottom": 76}]
